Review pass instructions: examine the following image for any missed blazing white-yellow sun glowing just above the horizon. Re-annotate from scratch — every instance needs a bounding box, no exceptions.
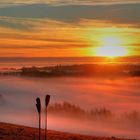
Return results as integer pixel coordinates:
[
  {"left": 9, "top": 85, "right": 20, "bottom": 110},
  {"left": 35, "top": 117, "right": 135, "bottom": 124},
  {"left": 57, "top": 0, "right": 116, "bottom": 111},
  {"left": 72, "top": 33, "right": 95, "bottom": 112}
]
[{"left": 95, "top": 37, "right": 127, "bottom": 58}]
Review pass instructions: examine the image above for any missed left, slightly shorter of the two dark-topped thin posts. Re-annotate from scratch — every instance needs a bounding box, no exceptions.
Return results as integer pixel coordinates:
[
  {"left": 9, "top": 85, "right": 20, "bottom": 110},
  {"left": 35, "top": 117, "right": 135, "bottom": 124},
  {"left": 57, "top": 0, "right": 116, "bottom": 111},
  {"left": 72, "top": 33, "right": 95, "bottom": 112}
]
[{"left": 36, "top": 98, "right": 41, "bottom": 140}]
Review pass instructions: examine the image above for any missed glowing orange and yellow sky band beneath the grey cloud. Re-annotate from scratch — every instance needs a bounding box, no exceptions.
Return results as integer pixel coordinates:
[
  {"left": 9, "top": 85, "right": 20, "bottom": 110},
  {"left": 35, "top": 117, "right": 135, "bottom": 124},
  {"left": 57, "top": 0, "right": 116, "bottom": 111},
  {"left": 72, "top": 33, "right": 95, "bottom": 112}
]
[{"left": 0, "top": 3, "right": 140, "bottom": 57}]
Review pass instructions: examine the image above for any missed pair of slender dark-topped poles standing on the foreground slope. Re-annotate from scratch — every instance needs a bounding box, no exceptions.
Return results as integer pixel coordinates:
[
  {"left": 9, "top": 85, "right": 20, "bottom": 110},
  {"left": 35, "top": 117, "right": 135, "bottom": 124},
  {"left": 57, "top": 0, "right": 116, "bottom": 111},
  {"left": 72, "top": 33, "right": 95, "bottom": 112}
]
[{"left": 36, "top": 95, "right": 50, "bottom": 140}]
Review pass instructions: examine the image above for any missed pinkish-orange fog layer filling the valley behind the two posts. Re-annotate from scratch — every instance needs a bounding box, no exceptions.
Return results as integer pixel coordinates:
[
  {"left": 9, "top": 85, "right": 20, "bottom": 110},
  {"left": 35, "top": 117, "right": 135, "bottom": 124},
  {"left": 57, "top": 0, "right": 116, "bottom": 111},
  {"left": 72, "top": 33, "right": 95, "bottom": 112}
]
[{"left": 0, "top": 77, "right": 140, "bottom": 138}]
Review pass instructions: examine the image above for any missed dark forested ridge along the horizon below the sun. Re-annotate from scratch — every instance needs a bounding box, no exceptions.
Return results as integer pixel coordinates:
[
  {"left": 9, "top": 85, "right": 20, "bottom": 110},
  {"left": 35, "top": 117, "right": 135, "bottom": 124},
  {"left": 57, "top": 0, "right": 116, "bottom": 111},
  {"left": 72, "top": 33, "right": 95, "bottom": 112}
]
[{"left": 0, "top": 63, "right": 140, "bottom": 77}]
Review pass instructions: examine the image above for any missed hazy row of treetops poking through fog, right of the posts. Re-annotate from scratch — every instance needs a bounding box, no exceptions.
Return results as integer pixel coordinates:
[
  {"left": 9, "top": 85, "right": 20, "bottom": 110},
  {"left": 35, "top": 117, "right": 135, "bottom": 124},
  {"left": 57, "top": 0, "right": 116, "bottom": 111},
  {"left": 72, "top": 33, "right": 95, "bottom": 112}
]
[{"left": 48, "top": 102, "right": 140, "bottom": 127}]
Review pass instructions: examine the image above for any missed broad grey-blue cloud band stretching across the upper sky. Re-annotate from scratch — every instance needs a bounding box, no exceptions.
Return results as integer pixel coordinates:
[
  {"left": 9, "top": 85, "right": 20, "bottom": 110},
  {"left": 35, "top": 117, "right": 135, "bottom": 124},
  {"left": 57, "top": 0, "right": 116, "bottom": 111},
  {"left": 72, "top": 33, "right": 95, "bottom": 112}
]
[{"left": 0, "top": 4, "right": 140, "bottom": 26}]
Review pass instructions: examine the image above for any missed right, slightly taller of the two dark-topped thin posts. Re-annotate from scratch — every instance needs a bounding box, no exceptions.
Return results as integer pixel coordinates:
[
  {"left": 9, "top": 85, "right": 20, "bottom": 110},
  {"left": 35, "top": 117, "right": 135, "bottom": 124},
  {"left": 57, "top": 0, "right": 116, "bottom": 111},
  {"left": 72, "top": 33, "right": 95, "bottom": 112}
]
[{"left": 45, "top": 95, "right": 50, "bottom": 140}]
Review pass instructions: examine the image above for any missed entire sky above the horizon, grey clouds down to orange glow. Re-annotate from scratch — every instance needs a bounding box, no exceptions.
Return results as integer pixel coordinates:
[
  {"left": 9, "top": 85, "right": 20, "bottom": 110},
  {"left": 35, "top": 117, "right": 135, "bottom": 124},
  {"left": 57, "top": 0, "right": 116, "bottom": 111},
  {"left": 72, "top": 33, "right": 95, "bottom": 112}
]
[{"left": 0, "top": 0, "right": 140, "bottom": 57}]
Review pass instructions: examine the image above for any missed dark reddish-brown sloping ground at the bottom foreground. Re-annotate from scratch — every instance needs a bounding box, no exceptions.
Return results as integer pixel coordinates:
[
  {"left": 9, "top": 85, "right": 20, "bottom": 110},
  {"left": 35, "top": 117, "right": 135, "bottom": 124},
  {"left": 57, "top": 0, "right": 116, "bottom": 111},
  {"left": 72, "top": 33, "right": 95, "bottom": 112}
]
[{"left": 0, "top": 123, "right": 135, "bottom": 140}]
